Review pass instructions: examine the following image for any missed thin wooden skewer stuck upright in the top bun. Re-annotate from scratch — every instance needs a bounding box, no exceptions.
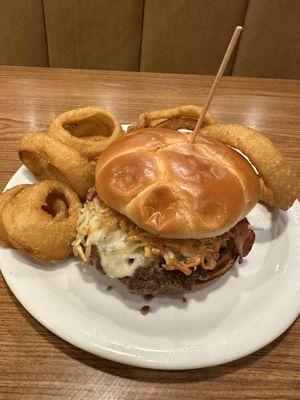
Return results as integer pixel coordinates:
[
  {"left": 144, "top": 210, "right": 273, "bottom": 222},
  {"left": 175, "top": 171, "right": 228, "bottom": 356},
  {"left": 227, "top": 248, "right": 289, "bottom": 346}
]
[{"left": 191, "top": 26, "right": 243, "bottom": 143}]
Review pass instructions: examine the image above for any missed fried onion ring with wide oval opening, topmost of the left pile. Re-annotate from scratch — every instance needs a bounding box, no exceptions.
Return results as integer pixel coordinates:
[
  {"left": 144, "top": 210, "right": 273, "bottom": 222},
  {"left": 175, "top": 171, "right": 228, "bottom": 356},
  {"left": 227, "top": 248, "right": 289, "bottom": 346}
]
[{"left": 48, "top": 107, "right": 123, "bottom": 160}]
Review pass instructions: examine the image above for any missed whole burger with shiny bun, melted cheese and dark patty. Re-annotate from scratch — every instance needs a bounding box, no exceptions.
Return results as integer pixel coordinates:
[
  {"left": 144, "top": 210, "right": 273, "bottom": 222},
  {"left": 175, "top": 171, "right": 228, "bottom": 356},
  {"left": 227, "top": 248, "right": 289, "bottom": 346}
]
[{"left": 73, "top": 128, "right": 260, "bottom": 295}]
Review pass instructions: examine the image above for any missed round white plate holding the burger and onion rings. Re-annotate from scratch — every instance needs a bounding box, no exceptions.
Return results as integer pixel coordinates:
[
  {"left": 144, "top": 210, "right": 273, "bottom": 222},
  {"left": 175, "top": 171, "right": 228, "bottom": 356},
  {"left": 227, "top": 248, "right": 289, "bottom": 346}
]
[{"left": 0, "top": 167, "right": 300, "bottom": 369}]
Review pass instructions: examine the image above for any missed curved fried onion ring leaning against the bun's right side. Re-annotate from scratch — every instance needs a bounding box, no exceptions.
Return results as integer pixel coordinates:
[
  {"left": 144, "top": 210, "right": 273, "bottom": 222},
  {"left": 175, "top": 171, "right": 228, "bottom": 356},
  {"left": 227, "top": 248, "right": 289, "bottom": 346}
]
[{"left": 196, "top": 124, "right": 300, "bottom": 210}]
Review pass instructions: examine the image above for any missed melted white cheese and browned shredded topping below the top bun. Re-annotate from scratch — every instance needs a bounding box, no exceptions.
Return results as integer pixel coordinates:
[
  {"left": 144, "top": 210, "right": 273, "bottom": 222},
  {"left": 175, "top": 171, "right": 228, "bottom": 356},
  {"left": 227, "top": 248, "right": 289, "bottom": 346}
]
[{"left": 73, "top": 197, "right": 225, "bottom": 278}]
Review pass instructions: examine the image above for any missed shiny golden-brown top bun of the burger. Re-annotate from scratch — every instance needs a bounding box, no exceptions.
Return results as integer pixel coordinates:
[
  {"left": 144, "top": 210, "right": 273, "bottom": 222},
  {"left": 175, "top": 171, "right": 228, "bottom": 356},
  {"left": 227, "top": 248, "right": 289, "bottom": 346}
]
[{"left": 96, "top": 128, "right": 260, "bottom": 239}]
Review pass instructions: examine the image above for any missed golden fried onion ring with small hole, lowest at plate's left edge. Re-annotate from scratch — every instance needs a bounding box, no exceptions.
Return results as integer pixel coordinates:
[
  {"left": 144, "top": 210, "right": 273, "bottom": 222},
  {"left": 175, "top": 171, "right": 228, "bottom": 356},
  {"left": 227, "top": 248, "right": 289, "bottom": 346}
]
[{"left": 2, "top": 180, "right": 81, "bottom": 261}]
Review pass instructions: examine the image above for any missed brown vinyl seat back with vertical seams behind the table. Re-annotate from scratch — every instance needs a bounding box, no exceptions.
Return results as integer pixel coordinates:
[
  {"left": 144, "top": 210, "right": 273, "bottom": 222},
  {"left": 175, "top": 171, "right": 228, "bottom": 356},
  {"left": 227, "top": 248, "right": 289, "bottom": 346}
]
[{"left": 0, "top": 0, "right": 300, "bottom": 79}]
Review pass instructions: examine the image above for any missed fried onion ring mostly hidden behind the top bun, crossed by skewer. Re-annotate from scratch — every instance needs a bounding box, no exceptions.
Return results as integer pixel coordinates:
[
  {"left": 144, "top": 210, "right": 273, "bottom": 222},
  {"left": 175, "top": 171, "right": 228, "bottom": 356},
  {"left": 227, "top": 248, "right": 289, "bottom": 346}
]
[{"left": 128, "top": 106, "right": 216, "bottom": 132}]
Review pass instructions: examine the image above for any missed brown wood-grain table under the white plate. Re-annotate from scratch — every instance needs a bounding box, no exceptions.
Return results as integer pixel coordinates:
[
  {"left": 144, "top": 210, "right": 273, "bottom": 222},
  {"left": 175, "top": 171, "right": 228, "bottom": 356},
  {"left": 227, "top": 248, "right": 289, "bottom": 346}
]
[{"left": 0, "top": 67, "right": 300, "bottom": 400}]
